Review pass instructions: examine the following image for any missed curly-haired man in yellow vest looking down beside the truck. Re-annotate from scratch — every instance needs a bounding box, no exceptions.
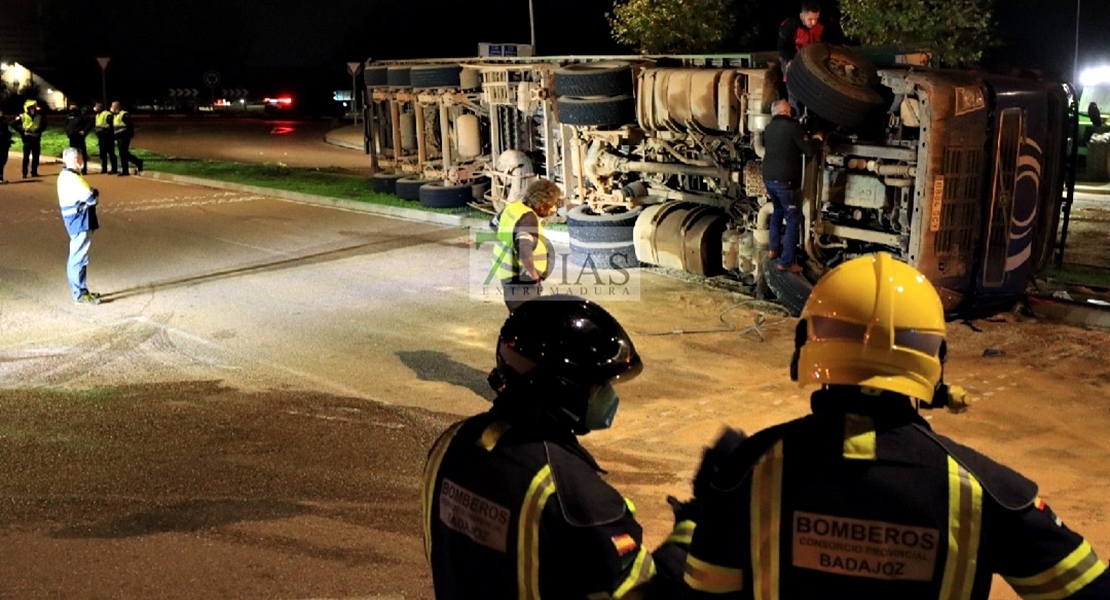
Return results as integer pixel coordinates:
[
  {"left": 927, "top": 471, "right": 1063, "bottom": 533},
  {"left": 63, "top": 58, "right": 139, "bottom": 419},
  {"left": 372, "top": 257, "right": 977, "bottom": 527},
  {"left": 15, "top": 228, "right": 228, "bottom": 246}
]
[{"left": 491, "top": 180, "right": 563, "bottom": 314}]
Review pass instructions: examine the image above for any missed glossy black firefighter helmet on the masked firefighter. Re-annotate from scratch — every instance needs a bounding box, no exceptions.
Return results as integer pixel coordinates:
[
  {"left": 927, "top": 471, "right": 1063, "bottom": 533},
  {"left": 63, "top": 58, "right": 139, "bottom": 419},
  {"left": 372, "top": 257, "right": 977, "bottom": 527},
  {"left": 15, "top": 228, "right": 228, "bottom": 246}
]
[{"left": 491, "top": 295, "right": 643, "bottom": 434}]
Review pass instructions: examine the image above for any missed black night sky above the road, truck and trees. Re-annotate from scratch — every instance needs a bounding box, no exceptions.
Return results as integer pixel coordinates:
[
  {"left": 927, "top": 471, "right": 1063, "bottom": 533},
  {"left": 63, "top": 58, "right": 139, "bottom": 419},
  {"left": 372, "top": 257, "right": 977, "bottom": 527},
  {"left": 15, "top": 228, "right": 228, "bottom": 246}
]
[{"left": 21, "top": 0, "right": 1110, "bottom": 111}]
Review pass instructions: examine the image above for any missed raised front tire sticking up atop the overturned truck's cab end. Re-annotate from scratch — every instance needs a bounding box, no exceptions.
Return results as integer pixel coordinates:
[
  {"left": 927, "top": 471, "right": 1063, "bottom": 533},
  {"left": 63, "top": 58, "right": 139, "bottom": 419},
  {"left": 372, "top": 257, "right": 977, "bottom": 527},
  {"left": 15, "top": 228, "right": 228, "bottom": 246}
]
[{"left": 786, "top": 43, "right": 882, "bottom": 128}]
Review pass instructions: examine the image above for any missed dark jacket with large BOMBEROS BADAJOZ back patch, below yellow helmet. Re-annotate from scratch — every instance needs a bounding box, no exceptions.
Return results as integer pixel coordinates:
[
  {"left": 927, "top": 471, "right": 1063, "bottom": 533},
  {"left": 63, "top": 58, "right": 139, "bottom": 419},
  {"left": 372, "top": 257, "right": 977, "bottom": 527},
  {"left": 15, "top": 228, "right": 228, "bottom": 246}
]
[{"left": 685, "top": 388, "right": 1110, "bottom": 600}]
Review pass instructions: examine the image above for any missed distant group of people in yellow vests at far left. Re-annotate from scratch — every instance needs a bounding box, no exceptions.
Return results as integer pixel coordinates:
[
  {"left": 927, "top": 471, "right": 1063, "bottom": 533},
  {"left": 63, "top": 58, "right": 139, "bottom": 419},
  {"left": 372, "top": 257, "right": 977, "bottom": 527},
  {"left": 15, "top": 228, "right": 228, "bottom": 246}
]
[{"left": 0, "top": 100, "right": 143, "bottom": 183}]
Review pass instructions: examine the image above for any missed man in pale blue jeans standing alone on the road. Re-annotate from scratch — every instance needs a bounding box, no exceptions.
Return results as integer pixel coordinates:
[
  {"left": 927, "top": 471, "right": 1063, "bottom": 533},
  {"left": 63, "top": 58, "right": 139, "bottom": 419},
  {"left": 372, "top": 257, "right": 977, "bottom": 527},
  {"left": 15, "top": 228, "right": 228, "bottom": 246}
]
[{"left": 58, "top": 148, "right": 100, "bottom": 305}]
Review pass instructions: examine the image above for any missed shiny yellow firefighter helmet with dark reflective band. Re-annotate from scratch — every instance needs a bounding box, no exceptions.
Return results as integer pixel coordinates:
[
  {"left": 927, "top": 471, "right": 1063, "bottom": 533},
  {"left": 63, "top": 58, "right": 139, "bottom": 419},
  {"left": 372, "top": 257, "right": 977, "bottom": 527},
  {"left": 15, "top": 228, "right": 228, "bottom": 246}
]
[{"left": 790, "top": 252, "right": 947, "bottom": 401}]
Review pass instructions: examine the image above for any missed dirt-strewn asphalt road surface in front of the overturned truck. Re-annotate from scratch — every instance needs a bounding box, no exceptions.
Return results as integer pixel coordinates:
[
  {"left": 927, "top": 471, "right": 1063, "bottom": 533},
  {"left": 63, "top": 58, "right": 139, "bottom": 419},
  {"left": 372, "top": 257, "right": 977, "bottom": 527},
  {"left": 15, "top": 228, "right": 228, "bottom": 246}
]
[{"left": 0, "top": 122, "right": 1110, "bottom": 599}]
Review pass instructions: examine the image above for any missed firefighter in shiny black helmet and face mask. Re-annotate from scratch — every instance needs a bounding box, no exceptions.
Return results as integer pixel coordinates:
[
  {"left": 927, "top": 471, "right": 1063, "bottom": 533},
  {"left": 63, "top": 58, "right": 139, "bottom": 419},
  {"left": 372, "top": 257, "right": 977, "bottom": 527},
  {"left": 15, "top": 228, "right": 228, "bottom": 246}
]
[{"left": 422, "top": 295, "right": 741, "bottom": 600}]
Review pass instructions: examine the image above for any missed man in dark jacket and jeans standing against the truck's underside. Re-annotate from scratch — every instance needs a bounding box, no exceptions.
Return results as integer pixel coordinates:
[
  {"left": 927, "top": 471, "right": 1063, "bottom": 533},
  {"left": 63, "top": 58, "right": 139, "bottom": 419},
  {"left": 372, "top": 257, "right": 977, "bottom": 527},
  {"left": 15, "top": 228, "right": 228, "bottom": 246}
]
[{"left": 763, "top": 100, "right": 821, "bottom": 273}]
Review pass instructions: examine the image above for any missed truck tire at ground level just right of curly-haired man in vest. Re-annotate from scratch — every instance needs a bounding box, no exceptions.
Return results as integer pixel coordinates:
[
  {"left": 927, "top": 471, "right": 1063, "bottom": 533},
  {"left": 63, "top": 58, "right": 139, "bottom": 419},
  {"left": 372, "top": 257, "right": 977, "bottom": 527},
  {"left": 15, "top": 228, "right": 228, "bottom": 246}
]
[{"left": 566, "top": 204, "right": 644, "bottom": 268}]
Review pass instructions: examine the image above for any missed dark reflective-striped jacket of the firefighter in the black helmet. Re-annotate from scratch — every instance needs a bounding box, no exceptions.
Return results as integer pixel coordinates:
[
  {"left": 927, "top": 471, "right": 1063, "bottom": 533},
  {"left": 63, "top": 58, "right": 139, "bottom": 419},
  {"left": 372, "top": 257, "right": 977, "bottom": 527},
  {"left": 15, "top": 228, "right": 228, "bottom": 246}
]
[{"left": 422, "top": 406, "right": 693, "bottom": 600}]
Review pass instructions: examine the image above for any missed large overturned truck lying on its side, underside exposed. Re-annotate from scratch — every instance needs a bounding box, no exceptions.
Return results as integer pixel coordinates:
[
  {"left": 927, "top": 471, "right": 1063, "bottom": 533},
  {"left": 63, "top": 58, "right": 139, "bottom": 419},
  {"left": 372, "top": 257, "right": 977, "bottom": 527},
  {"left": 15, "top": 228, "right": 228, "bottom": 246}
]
[{"left": 364, "top": 44, "right": 1076, "bottom": 317}]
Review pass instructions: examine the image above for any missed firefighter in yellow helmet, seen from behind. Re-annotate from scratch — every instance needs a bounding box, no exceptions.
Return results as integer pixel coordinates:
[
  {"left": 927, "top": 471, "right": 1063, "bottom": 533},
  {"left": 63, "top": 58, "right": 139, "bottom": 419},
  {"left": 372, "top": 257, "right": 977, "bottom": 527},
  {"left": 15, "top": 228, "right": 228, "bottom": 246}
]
[{"left": 684, "top": 253, "right": 1110, "bottom": 600}]
